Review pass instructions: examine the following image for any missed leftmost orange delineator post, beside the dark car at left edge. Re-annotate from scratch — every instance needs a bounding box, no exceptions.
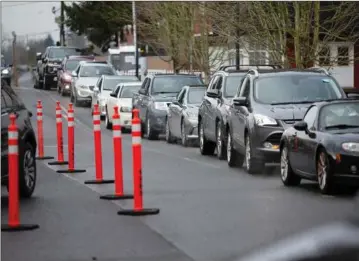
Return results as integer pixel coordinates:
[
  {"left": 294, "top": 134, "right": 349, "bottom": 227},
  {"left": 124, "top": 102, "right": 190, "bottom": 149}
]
[{"left": 1, "top": 114, "right": 39, "bottom": 231}]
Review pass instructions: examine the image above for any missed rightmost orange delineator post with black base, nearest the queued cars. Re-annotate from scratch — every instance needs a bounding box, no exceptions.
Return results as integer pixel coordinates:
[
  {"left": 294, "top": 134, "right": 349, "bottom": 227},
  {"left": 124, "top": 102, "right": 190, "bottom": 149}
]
[{"left": 117, "top": 109, "right": 160, "bottom": 216}]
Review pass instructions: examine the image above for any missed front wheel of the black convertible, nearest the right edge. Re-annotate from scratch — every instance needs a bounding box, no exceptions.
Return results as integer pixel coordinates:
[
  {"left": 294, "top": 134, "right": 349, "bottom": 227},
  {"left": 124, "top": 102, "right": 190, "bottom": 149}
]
[{"left": 316, "top": 149, "right": 334, "bottom": 194}]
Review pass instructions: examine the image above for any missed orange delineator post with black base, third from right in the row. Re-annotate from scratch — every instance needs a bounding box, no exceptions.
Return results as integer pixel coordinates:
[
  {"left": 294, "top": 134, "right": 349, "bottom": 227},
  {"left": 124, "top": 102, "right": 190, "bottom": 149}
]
[{"left": 85, "top": 104, "right": 115, "bottom": 184}]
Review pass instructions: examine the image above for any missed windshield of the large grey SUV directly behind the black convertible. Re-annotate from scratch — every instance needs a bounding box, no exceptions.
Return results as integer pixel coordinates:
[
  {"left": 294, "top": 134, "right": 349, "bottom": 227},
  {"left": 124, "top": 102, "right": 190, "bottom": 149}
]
[{"left": 254, "top": 75, "right": 342, "bottom": 104}]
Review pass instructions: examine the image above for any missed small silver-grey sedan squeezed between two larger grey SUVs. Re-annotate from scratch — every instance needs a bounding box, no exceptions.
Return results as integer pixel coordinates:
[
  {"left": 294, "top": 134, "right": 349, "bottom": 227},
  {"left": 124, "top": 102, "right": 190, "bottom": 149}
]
[{"left": 166, "top": 85, "right": 207, "bottom": 147}]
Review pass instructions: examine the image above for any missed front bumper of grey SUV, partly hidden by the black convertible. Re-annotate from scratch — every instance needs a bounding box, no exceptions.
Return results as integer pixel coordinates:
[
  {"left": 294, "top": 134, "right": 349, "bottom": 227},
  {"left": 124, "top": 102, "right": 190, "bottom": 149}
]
[{"left": 251, "top": 126, "right": 284, "bottom": 163}]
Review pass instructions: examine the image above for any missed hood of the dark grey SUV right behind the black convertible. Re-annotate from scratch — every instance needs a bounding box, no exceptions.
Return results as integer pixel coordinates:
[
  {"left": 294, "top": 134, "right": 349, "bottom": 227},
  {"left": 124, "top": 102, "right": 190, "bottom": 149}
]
[{"left": 257, "top": 104, "right": 311, "bottom": 120}]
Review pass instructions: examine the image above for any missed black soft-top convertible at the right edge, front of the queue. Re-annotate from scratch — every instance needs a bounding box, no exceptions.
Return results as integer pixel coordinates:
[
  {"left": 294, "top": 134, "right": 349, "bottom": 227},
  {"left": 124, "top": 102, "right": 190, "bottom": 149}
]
[{"left": 280, "top": 100, "right": 359, "bottom": 194}]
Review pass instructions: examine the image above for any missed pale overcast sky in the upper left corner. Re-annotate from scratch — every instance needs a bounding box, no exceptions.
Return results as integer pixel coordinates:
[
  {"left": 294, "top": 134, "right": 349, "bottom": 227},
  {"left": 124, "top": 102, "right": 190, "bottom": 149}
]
[{"left": 0, "top": 1, "right": 60, "bottom": 42}]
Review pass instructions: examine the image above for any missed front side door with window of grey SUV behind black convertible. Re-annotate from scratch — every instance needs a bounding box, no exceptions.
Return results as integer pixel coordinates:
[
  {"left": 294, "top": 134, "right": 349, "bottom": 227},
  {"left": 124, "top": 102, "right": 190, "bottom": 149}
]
[{"left": 232, "top": 77, "right": 251, "bottom": 149}]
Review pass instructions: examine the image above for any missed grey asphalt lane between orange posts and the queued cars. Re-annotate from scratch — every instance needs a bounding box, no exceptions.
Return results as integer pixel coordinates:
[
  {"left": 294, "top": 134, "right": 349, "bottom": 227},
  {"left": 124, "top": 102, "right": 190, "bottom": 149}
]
[{"left": 11, "top": 72, "right": 355, "bottom": 261}]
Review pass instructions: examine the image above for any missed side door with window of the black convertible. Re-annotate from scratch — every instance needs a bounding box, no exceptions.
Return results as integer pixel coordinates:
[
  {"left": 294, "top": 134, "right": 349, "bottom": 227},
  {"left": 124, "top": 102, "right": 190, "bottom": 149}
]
[{"left": 289, "top": 106, "right": 318, "bottom": 173}]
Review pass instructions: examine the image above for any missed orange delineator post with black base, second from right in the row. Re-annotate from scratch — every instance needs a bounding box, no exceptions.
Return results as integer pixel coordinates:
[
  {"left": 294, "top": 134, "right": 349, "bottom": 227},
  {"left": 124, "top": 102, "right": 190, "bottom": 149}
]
[{"left": 100, "top": 106, "right": 133, "bottom": 200}]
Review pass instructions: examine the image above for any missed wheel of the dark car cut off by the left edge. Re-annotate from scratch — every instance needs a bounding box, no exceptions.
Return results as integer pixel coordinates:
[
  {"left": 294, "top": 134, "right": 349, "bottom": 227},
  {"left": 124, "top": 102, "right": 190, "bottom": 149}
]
[{"left": 19, "top": 142, "right": 36, "bottom": 198}]
